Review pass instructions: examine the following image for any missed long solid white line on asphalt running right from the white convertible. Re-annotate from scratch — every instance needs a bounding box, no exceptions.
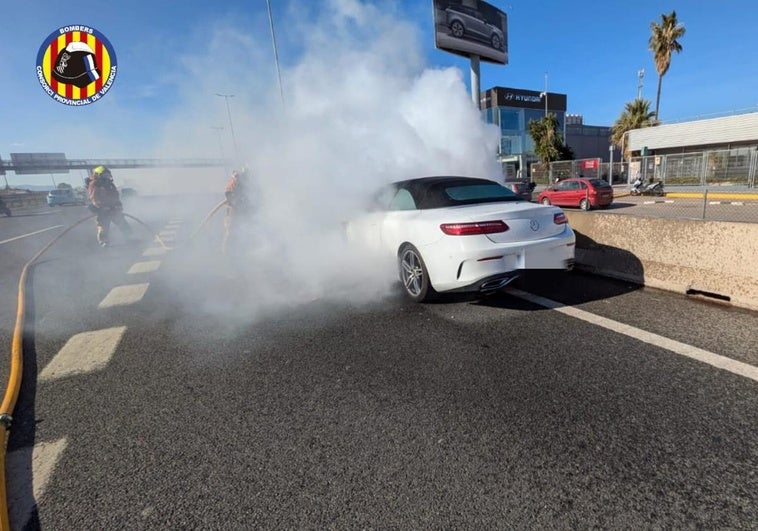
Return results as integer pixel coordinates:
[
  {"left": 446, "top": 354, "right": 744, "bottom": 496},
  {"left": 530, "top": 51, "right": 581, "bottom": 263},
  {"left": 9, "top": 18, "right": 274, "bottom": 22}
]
[{"left": 505, "top": 288, "right": 758, "bottom": 382}]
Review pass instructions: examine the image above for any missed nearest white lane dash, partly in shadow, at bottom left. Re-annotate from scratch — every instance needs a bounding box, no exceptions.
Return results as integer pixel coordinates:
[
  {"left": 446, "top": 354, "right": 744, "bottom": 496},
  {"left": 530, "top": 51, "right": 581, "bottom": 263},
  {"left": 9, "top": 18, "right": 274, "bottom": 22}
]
[{"left": 5, "top": 438, "right": 68, "bottom": 529}]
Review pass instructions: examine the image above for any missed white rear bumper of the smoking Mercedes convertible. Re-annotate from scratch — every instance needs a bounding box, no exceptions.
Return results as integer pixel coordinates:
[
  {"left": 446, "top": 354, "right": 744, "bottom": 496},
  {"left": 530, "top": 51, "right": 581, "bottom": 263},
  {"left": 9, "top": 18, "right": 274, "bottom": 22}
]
[{"left": 428, "top": 226, "right": 576, "bottom": 292}]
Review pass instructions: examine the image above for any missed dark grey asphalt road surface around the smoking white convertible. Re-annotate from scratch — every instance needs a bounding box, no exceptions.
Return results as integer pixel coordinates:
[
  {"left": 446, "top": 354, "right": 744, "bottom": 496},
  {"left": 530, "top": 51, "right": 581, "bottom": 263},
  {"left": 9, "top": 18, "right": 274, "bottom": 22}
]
[{"left": 0, "top": 198, "right": 758, "bottom": 529}]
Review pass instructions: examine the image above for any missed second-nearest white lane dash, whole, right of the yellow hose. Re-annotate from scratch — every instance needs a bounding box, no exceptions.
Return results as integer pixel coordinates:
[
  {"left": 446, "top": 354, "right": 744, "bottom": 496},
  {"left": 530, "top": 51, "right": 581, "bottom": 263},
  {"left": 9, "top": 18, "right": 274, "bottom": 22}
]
[{"left": 39, "top": 326, "right": 126, "bottom": 381}]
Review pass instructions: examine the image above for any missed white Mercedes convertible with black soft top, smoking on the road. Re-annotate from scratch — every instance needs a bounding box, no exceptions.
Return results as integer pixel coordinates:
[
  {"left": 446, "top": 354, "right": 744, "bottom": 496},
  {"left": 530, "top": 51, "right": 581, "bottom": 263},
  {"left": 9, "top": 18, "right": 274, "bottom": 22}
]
[{"left": 346, "top": 176, "right": 575, "bottom": 302}]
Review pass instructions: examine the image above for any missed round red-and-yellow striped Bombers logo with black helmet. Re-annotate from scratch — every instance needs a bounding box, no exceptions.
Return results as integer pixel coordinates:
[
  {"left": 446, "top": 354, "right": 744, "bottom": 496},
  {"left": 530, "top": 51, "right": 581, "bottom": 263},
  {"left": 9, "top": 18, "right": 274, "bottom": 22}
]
[{"left": 37, "top": 25, "right": 117, "bottom": 106}]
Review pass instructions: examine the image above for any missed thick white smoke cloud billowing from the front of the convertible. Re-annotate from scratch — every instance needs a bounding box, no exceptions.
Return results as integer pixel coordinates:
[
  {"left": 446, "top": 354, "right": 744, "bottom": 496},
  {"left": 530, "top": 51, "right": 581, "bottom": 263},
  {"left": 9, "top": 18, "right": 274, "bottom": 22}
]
[{"left": 148, "top": 0, "right": 501, "bottom": 328}]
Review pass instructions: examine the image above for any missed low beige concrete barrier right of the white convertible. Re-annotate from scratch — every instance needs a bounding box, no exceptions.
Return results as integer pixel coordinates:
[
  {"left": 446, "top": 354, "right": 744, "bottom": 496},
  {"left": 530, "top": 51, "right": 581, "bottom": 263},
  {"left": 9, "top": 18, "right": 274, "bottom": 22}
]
[{"left": 565, "top": 210, "right": 758, "bottom": 310}]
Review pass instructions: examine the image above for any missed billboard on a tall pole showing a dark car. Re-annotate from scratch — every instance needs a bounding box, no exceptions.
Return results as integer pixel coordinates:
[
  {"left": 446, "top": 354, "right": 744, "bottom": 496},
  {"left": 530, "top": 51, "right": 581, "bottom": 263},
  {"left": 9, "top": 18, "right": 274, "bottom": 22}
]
[{"left": 432, "top": 0, "right": 508, "bottom": 65}]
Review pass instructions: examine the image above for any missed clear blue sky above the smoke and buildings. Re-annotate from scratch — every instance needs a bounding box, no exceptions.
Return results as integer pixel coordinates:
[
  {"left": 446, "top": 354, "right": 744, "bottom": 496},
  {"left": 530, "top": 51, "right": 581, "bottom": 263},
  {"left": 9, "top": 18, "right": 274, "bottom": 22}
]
[{"left": 0, "top": 0, "right": 758, "bottom": 186}]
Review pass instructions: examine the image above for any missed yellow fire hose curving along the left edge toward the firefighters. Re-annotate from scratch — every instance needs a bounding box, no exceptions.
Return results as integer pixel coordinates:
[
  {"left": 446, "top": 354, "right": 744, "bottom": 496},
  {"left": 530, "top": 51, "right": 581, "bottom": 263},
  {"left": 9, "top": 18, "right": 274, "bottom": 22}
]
[{"left": 0, "top": 210, "right": 177, "bottom": 531}]
